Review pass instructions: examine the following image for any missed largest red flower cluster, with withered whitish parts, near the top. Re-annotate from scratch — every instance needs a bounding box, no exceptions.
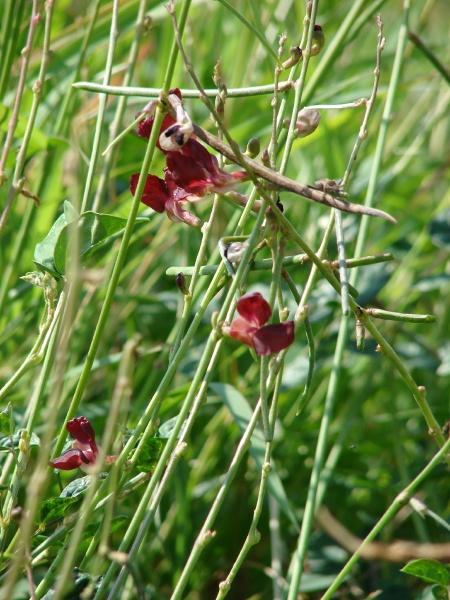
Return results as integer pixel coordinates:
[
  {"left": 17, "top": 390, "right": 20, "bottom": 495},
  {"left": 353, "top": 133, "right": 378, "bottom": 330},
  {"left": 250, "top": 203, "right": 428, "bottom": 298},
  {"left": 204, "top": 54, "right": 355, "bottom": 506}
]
[{"left": 130, "top": 89, "right": 247, "bottom": 227}]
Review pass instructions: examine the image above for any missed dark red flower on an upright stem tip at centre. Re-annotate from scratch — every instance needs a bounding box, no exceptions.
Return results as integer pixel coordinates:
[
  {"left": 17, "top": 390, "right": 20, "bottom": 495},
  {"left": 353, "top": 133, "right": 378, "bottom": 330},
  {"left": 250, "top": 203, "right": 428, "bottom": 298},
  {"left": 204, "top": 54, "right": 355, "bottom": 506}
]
[{"left": 225, "top": 292, "right": 294, "bottom": 356}]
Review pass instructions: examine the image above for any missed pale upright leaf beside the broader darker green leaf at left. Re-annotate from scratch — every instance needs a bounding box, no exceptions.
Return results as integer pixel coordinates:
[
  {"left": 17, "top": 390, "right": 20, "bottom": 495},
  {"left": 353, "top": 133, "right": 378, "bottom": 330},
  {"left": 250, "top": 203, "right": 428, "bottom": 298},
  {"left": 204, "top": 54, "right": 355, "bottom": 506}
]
[{"left": 33, "top": 200, "right": 78, "bottom": 279}]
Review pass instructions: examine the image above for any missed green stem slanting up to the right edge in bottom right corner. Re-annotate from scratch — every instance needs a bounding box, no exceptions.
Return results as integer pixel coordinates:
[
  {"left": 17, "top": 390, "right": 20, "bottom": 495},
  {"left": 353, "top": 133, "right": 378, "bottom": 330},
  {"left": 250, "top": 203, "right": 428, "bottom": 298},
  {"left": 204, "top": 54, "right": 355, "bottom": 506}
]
[{"left": 322, "top": 439, "right": 450, "bottom": 600}]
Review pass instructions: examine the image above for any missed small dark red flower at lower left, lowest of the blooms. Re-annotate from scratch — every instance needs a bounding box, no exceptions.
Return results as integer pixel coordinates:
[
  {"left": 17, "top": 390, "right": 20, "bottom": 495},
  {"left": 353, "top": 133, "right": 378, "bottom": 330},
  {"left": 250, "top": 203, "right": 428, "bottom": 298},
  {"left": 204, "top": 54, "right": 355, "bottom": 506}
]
[{"left": 50, "top": 417, "right": 98, "bottom": 471}]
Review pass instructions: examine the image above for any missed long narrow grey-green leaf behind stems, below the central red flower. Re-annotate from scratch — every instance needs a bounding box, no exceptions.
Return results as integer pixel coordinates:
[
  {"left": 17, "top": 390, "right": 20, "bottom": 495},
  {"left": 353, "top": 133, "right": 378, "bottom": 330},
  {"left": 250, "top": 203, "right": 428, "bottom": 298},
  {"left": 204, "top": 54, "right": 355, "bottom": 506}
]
[{"left": 210, "top": 383, "right": 299, "bottom": 528}]
